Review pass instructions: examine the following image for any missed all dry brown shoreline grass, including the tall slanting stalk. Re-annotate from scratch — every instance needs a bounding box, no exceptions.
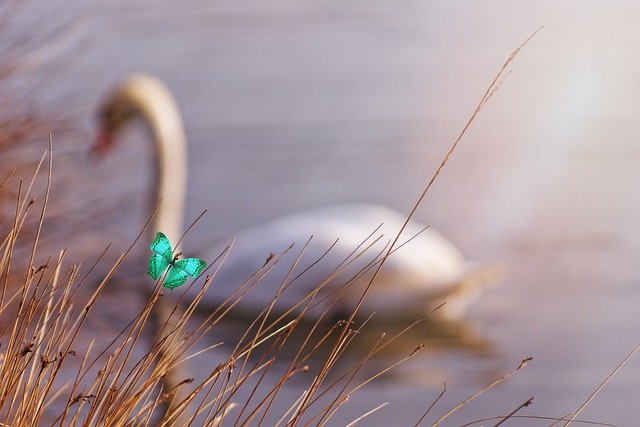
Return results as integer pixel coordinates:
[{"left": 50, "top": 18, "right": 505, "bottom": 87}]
[{"left": 0, "top": 24, "right": 638, "bottom": 427}]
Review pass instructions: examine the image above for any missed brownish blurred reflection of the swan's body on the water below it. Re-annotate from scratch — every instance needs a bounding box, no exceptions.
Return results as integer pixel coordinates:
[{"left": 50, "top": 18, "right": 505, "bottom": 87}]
[{"left": 201, "top": 298, "right": 498, "bottom": 385}]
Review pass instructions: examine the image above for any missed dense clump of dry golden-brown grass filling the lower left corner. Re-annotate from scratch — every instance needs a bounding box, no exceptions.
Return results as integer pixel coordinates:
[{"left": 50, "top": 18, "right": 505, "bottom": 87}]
[{"left": 0, "top": 134, "right": 442, "bottom": 426}]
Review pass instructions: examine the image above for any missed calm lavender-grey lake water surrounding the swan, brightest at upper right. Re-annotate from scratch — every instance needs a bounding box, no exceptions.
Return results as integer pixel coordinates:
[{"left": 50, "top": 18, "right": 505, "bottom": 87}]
[{"left": 6, "top": 0, "right": 640, "bottom": 425}]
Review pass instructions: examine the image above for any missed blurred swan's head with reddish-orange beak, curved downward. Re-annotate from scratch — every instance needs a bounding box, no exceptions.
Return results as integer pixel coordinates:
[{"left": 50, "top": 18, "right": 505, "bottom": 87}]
[{"left": 92, "top": 74, "right": 179, "bottom": 154}]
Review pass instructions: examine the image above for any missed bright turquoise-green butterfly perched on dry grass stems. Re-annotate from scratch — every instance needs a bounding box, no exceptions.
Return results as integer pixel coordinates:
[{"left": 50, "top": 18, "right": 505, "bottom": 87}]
[{"left": 147, "top": 233, "right": 207, "bottom": 289}]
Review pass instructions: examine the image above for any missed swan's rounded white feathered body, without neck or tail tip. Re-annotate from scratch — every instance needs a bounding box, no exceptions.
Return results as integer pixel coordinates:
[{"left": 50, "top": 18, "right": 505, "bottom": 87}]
[{"left": 202, "top": 204, "right": 478, "bottom": 311}]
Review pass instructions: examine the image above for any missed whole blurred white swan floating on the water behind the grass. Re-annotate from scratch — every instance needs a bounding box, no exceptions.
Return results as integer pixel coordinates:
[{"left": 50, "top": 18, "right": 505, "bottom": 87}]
[{"left": 95, "top": 74, "right": 493, "bottom": 320}]
